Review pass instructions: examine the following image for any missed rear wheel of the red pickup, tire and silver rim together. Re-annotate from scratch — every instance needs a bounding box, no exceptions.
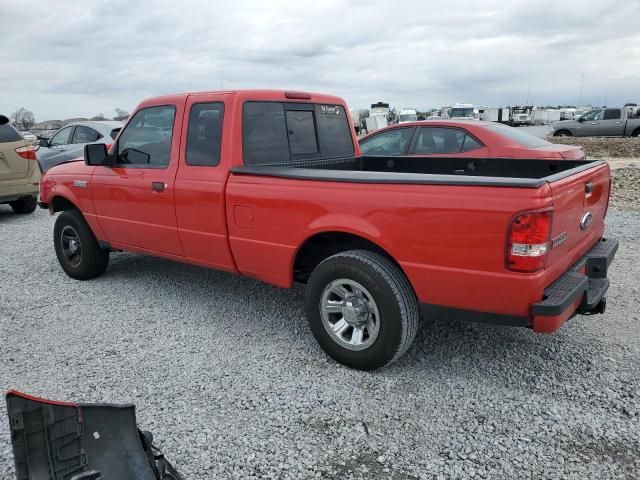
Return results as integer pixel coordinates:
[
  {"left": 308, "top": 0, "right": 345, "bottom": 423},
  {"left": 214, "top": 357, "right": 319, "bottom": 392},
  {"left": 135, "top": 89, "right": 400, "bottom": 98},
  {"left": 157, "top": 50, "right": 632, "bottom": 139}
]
[{"left": 305, "top": 250, "right": 419, "bottom": 370}]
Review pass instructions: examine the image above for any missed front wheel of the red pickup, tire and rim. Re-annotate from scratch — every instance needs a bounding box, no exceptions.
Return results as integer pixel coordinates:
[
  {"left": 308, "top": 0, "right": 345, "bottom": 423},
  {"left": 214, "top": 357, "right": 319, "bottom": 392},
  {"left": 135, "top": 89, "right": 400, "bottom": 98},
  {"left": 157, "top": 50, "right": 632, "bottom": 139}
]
[{"left": 53, "top": 209, "right": 109, "bottom": 280}]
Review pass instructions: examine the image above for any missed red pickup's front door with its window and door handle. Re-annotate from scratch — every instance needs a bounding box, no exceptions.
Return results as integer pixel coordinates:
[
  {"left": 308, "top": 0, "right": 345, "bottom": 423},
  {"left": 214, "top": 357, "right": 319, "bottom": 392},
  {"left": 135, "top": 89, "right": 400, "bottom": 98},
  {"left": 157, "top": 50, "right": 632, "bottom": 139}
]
[{"left": 91, "top": 104, "right": 183, "bottom": 256}]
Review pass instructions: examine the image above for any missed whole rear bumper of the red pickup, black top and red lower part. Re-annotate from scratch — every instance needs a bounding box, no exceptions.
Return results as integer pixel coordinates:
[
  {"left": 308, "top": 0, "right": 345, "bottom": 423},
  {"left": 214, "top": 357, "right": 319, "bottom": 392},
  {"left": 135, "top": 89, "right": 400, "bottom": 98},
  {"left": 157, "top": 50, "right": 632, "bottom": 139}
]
[{"left": 531, "top": 238, "right": 618, "bottom": 333}]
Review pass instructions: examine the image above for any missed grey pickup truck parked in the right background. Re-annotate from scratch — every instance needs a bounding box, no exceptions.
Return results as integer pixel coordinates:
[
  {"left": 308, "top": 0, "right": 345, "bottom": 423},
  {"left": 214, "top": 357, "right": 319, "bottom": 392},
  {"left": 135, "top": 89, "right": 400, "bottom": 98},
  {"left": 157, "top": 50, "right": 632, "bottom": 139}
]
[{"left": 551, "top": 107, "right": 640, "bottom": 137}]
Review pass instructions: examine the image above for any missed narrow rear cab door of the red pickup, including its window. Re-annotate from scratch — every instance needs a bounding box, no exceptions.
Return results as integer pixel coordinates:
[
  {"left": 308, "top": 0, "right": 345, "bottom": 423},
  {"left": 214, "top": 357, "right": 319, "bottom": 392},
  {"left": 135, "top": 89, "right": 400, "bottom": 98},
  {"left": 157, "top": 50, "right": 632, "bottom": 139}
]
[{"left": 175, "top": 94, "right": 235, "bottom": 271}]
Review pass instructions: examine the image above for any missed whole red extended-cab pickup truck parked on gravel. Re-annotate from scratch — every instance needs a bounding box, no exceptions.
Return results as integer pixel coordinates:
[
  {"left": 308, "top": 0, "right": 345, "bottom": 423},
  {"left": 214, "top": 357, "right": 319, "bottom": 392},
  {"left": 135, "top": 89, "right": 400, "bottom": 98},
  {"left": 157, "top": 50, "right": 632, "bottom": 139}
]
[{"left": 40, "top": 91, "right": 618, "bottom": 369}]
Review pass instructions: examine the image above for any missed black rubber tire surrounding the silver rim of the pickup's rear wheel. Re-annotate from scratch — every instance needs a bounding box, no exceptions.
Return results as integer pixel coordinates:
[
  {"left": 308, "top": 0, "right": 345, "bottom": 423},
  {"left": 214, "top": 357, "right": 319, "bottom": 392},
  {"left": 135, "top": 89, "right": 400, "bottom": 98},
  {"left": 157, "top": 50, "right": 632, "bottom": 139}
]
[{"left": 305, "top": 250, "right": 420, "bottom": 370}]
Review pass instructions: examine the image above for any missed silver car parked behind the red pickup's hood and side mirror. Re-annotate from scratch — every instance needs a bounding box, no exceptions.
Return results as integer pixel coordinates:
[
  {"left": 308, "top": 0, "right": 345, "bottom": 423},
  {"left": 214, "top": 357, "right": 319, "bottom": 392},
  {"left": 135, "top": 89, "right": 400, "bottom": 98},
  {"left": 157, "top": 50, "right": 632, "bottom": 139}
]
[{"left": 36, "top": 121, "right": 122, "bottom": 172}]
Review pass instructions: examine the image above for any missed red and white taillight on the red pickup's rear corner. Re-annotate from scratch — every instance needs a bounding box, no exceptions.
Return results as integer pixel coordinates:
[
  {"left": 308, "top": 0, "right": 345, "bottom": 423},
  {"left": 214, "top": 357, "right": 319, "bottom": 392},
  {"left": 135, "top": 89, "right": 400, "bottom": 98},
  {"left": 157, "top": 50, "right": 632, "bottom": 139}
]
[{"left": 507, "top": 211, "right": 551, "bottom": 272}]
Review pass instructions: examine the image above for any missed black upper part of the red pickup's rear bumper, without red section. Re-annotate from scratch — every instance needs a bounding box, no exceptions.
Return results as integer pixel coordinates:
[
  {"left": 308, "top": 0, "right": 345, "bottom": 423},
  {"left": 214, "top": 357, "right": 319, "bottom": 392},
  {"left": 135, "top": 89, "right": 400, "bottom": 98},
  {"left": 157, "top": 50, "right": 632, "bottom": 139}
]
[{"left": 531, "top": 238, "right": 619, "bottom": 316}]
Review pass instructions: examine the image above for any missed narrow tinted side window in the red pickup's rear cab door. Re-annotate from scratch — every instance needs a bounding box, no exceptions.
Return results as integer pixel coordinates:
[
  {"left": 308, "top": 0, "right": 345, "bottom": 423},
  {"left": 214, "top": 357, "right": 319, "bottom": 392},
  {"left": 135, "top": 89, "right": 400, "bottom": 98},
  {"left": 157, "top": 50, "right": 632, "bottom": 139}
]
[{"left": 186, "top": 102, "right": 224, "bottom": 167}]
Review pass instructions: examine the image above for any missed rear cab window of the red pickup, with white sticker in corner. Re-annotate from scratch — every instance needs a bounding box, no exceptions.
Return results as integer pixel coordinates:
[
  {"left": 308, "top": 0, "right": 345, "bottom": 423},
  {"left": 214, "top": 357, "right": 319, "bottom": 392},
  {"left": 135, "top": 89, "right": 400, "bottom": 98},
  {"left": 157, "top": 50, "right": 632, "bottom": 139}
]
[{"left": 242, "top": 101, "right": 355, "bottom": 165}]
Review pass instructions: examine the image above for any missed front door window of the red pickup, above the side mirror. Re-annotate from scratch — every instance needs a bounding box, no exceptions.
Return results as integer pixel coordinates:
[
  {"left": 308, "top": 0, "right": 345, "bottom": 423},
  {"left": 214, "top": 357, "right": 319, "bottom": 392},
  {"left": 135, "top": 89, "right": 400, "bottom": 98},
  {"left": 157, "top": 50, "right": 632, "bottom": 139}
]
[{"left": 116, "top": 105, "right": 176, "bottom": 167}]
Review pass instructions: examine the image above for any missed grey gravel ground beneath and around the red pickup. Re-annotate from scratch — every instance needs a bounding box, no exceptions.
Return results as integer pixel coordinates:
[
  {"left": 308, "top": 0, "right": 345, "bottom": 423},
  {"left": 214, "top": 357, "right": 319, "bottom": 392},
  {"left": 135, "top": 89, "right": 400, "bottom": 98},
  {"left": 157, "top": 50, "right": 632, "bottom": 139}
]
[{"left": 0, "top": 206, "right": 640, "bottom": 479}]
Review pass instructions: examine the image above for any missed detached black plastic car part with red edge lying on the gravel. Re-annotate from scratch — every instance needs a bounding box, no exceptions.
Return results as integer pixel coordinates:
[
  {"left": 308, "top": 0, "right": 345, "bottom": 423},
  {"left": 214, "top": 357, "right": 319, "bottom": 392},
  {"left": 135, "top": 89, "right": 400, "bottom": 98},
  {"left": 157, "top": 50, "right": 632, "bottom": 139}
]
[{"left": 6, "top": 390, "right": 182, "bottom": 480}]
